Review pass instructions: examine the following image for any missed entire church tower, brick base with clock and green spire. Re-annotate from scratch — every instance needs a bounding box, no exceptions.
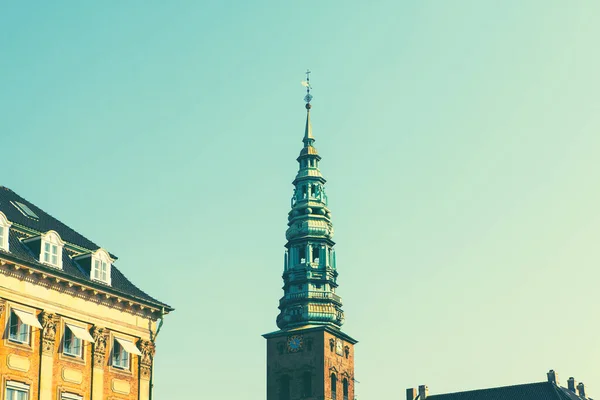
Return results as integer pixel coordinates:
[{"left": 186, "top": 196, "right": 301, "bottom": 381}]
[{"left": 263, "top": 71, "right": 357, "bottom": 400}]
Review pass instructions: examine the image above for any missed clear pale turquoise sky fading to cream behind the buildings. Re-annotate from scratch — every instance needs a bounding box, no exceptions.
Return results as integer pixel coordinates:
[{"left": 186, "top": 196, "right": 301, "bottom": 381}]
[{"left": 0, "top": 0, "right": 600, "bottom": 400}]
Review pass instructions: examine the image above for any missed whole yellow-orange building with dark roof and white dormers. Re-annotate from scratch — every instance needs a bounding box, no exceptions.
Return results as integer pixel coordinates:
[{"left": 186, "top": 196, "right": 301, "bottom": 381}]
[{"left": 0, "top": 186, "right": 173, "bottom": 400}]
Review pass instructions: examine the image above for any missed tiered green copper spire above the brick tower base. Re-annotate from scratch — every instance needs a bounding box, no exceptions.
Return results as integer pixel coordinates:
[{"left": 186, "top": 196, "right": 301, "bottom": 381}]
[{"left": 277, "top": 71, "right": 344, "bottom": 329}]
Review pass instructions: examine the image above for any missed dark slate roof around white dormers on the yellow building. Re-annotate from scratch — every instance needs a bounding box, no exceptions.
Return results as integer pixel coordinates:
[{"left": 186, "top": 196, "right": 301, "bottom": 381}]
[{"left": 0, "top": 186, "right": 173, "bottom": 311}]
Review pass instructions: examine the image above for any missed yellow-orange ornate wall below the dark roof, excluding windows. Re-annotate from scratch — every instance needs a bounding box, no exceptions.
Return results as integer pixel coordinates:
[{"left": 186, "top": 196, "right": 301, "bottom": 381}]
[{"left": 0, "top": 260, "right": 156, "bottom": 400}]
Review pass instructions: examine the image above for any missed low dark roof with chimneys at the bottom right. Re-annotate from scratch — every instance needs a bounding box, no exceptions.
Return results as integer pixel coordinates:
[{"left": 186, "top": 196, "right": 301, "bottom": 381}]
[{"left": 427, "top": 382, "right": 579, "bottom": 400}]
